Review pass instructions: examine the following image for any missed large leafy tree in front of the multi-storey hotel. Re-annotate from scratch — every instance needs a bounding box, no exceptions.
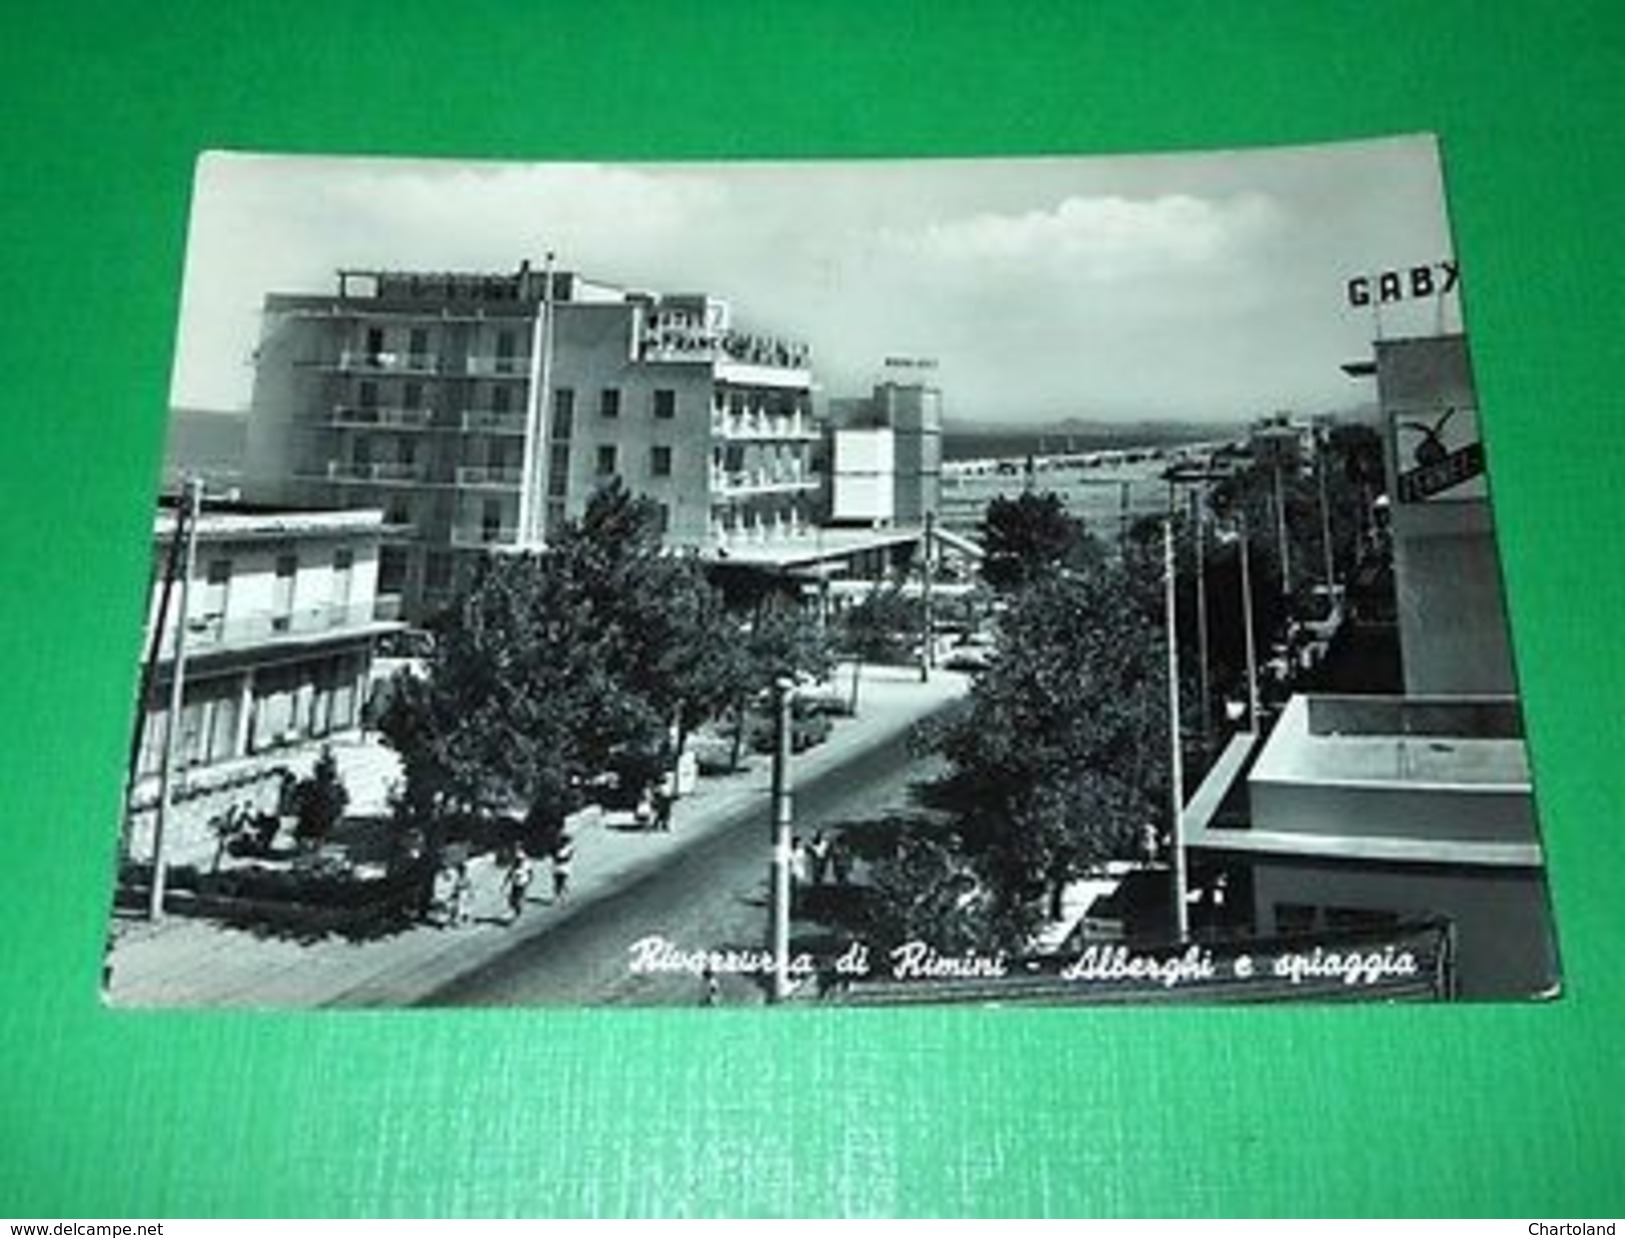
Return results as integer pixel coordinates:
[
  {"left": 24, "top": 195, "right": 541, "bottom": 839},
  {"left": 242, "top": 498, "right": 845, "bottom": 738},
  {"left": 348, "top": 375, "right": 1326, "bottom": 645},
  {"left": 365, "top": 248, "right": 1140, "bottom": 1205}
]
[{"left": 380, "top": 484, "right": 738, "bottom": 842}]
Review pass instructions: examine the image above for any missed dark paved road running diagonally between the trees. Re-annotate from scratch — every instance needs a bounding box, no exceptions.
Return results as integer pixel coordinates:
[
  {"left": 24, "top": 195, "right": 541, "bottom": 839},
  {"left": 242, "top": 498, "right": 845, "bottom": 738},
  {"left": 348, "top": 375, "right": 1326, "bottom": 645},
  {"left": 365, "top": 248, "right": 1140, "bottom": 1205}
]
[{"left": 427, "top": 714, "right": 931, "bottom": 1006}]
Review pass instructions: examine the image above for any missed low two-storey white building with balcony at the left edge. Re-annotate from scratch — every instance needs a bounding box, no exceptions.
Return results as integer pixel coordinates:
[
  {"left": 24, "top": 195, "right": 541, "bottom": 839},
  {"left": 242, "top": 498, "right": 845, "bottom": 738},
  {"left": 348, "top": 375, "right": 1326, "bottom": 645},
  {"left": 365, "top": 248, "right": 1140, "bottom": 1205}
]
[{"left": 128, "top": 510, "right": 401, "bottom": 856}]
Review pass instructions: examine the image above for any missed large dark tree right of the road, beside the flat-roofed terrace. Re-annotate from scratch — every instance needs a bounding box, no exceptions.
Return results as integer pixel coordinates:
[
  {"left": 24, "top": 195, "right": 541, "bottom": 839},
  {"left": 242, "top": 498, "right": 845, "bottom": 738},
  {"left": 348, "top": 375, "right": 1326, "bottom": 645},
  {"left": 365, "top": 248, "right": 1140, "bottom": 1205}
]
[{"left": 936, "top": 557, "right": 1168, "bottom": 946}]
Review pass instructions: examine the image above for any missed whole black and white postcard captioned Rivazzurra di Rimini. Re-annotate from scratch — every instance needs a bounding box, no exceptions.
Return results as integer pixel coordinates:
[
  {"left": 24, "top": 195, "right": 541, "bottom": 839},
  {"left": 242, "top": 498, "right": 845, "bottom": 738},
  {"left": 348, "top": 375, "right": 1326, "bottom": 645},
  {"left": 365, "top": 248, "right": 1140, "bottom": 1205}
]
[{"left": 102, "top": 135, "right": 1560, "bottom": 1017}]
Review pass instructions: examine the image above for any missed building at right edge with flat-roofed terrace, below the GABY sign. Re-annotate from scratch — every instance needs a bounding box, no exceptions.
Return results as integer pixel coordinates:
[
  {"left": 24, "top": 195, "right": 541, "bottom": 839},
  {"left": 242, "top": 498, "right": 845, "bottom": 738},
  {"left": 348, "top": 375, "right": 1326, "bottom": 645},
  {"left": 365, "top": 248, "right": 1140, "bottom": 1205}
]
[{"left": 1181, "top": 335, "right": 1558, "bottom": 998}]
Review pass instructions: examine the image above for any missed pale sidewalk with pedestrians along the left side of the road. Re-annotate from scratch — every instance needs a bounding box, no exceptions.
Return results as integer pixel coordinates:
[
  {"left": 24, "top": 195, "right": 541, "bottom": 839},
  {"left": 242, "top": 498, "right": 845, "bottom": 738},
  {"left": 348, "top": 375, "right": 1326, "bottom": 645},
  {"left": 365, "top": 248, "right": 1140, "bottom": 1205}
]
[{"left": 109, "top": 666, "right": 967, "bottom": 1007}]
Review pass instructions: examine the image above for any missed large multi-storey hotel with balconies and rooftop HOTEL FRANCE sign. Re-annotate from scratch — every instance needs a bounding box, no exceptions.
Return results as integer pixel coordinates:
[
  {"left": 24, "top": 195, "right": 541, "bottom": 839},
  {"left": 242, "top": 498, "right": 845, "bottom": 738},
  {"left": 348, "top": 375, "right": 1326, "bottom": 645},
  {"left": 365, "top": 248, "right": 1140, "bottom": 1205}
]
[{"left": 244, "top": 265, "right": 819, "bottom": 617}]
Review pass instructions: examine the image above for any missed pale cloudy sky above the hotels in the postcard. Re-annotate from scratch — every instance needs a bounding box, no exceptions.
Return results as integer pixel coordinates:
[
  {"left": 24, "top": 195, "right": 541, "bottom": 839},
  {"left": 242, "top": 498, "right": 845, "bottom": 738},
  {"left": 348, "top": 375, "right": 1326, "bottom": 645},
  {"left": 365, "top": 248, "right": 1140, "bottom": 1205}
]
[{"left": 174, "top": 138, "right": 1459, "bottom": 424}]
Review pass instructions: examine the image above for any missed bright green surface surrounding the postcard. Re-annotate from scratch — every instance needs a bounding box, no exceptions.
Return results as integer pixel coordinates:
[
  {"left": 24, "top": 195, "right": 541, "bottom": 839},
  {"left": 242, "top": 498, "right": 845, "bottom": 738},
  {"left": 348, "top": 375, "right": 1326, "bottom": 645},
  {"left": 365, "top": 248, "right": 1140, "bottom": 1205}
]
[{"left": 0, "top": 0, "right": 1625, "bottom": 1219}]
